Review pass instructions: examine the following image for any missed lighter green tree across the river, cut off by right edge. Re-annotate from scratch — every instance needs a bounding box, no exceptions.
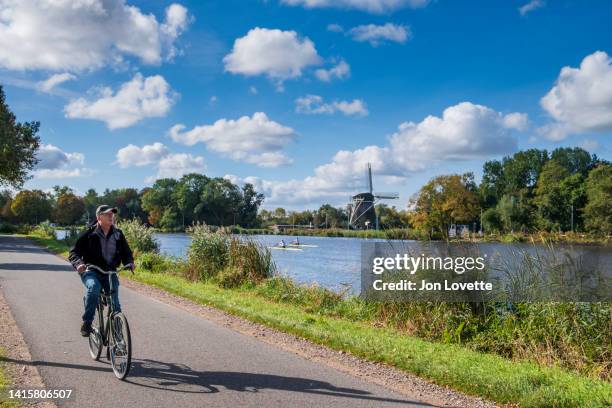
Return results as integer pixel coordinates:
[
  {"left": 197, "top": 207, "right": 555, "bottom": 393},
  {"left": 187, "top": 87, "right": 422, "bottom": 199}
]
[{"left": 584, "top": 164, "right": 612, "bottom": 235}]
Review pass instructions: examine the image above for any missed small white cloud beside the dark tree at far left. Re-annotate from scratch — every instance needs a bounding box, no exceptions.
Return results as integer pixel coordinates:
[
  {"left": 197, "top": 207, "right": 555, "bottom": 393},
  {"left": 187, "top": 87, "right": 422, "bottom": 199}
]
[{"left": 33, "top": 144, "right": 91, "bottom": 179}]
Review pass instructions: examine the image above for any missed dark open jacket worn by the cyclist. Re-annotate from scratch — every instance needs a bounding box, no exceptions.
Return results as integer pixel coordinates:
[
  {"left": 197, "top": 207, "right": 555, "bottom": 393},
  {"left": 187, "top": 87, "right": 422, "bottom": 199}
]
[{"left": 68, "top": 223, "right": 134, "bottom": 271}]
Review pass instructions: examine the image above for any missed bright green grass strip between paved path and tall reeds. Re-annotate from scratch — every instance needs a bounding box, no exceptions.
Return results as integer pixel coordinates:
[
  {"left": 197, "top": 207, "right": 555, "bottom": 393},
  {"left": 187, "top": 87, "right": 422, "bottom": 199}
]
[{"left": 20, "top": 231, "right": 612, "bottom": 407}]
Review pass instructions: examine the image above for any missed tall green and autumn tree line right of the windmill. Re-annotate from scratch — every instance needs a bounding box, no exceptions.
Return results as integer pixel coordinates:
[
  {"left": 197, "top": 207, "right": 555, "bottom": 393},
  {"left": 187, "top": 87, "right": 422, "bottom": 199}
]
[{"left": 409, "top": 147, "right": 612, "bottom": 237}]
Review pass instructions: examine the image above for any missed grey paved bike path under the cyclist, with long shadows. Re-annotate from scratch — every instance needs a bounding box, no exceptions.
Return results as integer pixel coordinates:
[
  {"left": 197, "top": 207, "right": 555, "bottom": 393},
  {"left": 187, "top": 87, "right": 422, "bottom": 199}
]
[{"left": 0, "top": 235, "right": 427, "bottom": 408}]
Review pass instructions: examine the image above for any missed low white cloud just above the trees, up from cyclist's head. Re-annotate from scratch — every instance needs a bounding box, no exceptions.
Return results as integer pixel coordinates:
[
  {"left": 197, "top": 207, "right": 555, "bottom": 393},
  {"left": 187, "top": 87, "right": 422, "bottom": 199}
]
[{"left": 116, "top": 142, "right": 206, "bottom": 183}]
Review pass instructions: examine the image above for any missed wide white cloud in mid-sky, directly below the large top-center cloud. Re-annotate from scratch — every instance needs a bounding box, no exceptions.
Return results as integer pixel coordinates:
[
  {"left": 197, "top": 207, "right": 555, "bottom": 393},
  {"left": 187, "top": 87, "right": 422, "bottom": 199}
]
[{"left": 169, "top": 112, "right": 296, "bottom": 167}]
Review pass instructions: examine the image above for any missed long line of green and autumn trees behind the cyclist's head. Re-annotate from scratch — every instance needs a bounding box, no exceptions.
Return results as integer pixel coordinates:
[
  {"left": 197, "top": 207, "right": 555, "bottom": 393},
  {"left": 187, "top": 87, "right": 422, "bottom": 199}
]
[{"left": 0, "top": 173, "right": 264, "bottom": 231}]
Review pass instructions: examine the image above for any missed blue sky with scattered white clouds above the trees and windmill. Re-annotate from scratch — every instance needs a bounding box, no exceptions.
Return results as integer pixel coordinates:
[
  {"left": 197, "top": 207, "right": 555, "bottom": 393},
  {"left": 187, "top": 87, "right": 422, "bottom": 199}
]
[{"left": 0, "top": 0, "right": 612, "bottom": 208}]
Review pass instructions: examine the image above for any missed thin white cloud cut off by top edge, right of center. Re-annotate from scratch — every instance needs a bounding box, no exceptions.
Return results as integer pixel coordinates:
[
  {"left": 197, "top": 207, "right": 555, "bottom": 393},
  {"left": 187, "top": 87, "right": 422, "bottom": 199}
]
[{"left": 281, "top": 0, "right": 430, "bottom": 14}]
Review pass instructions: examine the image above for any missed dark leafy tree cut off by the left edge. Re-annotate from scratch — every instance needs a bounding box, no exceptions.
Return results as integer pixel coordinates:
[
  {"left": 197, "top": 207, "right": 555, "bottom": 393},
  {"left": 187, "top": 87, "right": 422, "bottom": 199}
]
[{"left": 0, "top": 86, "right": 40, "bottom": 188}]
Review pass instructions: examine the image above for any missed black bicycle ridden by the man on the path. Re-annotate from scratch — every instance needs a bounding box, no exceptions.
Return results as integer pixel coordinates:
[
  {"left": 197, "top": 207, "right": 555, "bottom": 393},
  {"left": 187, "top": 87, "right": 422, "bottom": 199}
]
[{"left": 83, "top": 264, "right": 132, "bottom": 380}]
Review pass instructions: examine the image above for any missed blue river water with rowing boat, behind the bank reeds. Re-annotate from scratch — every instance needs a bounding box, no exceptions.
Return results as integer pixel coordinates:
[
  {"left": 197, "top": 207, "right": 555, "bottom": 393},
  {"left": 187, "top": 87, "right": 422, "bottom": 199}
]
[{"left": 156, "top": 233, "right": 612, "bottom": 293}]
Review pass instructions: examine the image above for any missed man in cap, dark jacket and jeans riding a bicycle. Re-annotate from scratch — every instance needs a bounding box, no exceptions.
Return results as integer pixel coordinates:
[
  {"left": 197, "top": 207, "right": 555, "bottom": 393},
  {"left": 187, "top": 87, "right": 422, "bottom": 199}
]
[{"left": 68, "top": 205, "right": 134, "bottom": 337}]
